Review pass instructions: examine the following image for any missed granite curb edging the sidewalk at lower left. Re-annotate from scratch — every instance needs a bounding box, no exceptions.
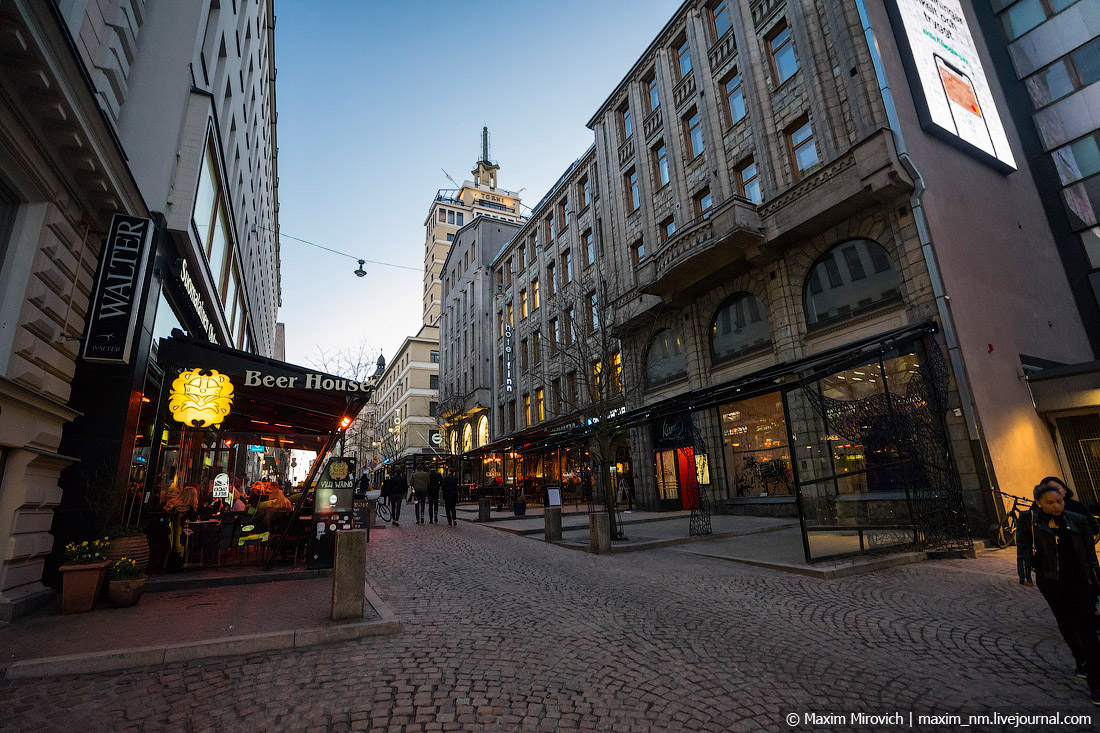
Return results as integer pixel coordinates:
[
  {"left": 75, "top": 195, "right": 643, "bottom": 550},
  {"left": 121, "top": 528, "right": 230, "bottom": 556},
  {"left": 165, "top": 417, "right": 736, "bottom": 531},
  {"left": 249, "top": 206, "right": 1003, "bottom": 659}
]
[{"left": 0, "top": 584, "right": 402, "bottom": 681}]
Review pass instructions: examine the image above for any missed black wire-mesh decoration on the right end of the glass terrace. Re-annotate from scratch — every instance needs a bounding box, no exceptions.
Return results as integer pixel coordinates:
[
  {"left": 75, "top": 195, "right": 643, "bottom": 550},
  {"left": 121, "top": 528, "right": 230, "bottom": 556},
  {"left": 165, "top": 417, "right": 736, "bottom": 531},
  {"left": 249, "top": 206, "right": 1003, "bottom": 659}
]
[{"left": 803, "top": 339, "right": 974, "bottom": 550}]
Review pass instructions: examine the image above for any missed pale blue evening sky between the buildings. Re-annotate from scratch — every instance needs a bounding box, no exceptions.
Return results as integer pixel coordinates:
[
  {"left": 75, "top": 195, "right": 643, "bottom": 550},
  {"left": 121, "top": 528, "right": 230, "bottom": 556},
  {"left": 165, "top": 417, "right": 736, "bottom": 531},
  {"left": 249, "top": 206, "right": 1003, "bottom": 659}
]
[{"left": 275, "top": 0, "right": 680, "bottom": 363}]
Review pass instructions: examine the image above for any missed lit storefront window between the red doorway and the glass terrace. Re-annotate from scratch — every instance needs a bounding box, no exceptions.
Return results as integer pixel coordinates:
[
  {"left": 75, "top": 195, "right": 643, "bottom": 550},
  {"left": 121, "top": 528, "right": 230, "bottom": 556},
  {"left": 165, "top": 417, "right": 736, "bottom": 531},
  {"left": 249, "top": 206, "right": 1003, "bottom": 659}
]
[{"left": 719, "top": 392, "right": 794, "bottom": 497}]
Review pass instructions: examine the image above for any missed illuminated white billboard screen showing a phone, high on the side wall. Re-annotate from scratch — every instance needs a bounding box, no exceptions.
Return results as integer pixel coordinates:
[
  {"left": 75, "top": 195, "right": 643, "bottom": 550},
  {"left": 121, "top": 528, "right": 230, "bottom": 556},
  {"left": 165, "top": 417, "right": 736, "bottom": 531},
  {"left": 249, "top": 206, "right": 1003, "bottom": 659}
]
[{"left": 887, "top": 0, "right": 1016, "bottom": 173}]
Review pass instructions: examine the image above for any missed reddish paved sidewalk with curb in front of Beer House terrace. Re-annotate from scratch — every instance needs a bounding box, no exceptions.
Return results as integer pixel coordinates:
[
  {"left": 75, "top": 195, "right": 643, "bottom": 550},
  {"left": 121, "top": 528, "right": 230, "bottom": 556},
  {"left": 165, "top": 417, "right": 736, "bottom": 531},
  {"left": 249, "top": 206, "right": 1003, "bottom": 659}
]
[{"left": 0, "top": 578, "right": 400, "bottom": 677}]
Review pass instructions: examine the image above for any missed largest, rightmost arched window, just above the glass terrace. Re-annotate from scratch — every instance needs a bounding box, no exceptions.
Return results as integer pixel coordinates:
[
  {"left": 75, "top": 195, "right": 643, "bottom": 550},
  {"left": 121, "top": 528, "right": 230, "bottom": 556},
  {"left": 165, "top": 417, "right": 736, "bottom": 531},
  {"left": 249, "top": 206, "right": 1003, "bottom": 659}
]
[{"left": 805, "top": 239, "right": 901, "bottom": 326}]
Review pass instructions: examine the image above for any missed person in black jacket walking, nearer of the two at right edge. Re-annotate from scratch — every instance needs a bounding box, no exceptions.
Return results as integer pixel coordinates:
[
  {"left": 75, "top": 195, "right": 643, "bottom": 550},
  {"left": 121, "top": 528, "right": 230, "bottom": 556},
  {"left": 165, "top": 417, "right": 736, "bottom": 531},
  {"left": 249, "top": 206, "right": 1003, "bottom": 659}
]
[{"left": 1016, "top": 483, "right": 1100, "bottom": 705}]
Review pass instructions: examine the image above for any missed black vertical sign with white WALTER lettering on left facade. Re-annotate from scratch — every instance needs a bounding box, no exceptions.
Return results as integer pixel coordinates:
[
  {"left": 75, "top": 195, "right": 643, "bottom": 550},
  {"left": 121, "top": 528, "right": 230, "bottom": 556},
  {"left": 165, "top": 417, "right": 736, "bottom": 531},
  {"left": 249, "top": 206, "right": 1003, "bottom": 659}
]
[{"left": 81, "top": 214, "right": 154, "bottom": 364}]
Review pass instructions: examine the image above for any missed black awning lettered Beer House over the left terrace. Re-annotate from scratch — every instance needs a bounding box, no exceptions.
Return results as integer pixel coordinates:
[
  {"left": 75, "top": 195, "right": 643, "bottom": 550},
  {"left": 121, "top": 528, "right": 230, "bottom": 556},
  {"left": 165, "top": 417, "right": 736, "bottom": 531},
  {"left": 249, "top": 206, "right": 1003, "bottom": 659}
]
[{"left": 157, "top": 331, "right": 374, "bottom": 436}]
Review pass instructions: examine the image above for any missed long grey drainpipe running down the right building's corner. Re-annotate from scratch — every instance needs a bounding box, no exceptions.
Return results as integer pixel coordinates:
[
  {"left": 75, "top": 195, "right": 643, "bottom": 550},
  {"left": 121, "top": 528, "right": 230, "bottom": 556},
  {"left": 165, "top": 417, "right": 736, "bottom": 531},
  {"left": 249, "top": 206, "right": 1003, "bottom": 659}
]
[{"left": 855, "top": 0, "right": 1003, "bottom": 517}]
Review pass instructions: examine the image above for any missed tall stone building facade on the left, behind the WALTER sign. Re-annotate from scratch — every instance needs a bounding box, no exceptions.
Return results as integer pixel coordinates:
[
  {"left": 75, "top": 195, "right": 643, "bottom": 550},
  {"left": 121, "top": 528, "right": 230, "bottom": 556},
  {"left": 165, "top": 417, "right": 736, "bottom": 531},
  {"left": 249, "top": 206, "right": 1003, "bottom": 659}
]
[{"left": 0, "top": 0, "right": 281, "bottom": 619}]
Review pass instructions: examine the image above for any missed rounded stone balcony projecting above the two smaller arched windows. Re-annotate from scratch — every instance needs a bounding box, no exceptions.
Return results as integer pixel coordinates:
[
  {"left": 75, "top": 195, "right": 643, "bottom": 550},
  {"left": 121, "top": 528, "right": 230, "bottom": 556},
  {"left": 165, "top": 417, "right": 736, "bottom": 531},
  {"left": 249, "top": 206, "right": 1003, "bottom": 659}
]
[{"left": 639, "top": 196, "right": 767, "bottom": 297}]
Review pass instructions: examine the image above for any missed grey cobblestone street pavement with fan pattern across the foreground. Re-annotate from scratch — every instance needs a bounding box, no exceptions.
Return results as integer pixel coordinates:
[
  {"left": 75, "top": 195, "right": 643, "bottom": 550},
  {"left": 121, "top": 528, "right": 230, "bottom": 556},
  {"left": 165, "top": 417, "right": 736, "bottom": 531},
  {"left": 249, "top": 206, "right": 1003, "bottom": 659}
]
[{"left": 0, "top": 524, "right": 1100, "bottom": 732}]
